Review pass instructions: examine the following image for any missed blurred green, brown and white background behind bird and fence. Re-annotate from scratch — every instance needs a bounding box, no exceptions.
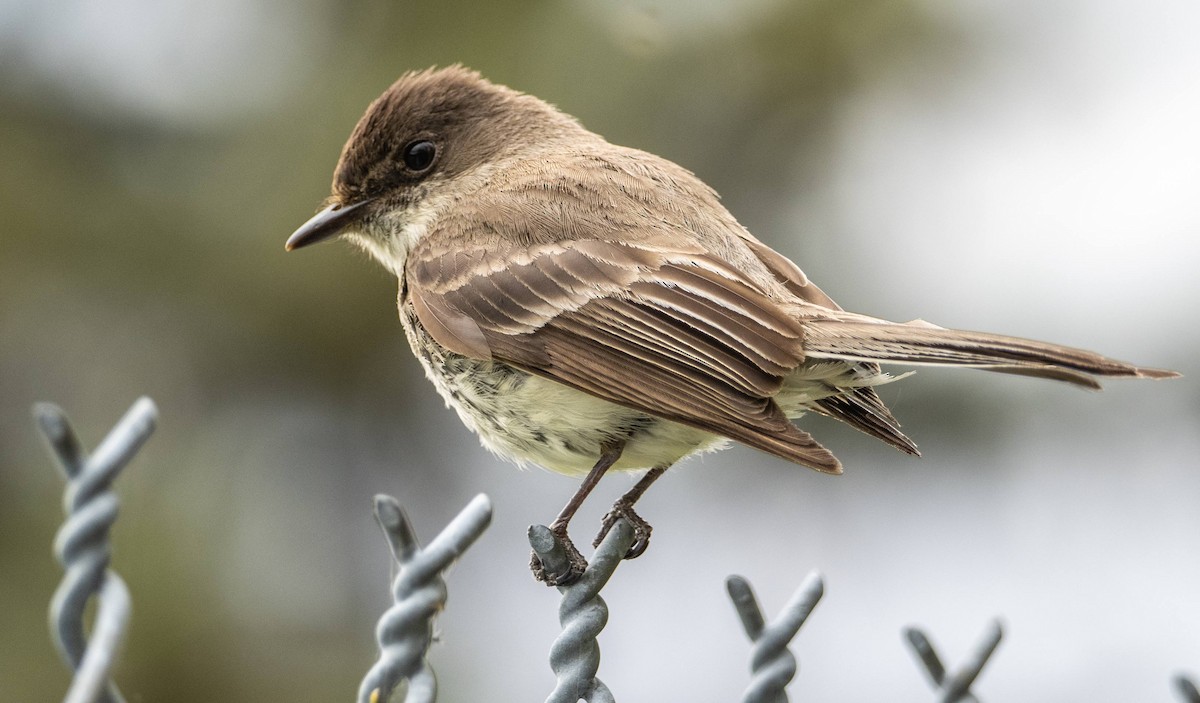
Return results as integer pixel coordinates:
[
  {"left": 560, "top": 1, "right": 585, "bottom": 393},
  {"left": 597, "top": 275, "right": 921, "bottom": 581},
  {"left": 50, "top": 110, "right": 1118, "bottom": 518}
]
[{"left": 0, "top": 0, "right": 1200, "bottom": 703}]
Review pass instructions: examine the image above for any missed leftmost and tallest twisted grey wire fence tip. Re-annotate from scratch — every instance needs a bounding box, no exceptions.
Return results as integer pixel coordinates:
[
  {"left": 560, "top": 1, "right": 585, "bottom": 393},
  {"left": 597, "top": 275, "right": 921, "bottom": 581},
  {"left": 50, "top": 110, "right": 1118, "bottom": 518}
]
[{"left": 34, "top": 397, "right": 158, "bottom": 703}]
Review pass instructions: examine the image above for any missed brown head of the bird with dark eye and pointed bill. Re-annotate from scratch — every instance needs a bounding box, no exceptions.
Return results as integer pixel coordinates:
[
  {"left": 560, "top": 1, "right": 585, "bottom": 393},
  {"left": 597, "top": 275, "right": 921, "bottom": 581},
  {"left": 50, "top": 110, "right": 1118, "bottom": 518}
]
[{"left": 286, "top": 66, "right": 586, "bottom": 274}]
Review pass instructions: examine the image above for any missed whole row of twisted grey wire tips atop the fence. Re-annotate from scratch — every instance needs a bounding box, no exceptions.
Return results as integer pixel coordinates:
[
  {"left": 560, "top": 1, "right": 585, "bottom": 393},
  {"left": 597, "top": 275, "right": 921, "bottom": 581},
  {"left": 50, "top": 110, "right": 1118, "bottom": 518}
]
[{"left": 34, "top": 397, "right": 1200, "bottom": 703}]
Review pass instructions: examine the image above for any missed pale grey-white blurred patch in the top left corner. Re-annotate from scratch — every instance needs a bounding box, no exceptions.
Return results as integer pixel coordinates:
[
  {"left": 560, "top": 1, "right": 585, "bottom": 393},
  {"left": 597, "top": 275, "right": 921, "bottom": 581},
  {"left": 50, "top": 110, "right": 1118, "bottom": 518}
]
[{"left": 0, "top": 0, "right": 323, "bottom": 122}]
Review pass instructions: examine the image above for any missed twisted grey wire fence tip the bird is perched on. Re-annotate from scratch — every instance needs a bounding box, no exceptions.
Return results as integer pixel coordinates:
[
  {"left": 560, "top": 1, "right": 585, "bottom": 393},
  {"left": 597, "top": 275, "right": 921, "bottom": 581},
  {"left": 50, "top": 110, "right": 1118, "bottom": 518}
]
[{"left": 529, "top": 519, "right": 634, "bottom": 703}]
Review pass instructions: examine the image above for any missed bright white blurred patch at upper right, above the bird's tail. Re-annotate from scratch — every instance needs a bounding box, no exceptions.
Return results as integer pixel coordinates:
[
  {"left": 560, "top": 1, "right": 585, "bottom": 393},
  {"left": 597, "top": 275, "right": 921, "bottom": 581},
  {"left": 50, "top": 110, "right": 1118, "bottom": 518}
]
[{"left": 829, "top": 2, "right": 1200, "bottom": 343}]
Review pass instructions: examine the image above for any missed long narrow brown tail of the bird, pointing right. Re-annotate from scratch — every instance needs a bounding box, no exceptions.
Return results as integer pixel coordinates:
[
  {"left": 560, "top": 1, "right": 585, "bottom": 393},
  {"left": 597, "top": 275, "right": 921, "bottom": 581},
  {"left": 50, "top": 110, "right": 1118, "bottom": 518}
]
[{"left": 804, "top": 319, "right": 1180, "bottom": 389}]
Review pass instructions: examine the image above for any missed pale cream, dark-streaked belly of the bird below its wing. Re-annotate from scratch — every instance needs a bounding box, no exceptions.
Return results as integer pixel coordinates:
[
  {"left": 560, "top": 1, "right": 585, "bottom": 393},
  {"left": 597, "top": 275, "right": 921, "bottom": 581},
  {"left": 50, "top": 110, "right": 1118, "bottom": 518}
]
[{"left": 404, "top": 304, "right": 727, "bottom": 475}]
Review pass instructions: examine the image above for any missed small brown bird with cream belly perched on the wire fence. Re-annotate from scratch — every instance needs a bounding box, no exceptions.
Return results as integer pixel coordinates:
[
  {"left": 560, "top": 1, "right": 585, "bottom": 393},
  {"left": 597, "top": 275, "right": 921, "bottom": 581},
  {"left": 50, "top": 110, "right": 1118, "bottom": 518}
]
[{"left": 286, "top": 65, "right": 1178, "bottom": 585}]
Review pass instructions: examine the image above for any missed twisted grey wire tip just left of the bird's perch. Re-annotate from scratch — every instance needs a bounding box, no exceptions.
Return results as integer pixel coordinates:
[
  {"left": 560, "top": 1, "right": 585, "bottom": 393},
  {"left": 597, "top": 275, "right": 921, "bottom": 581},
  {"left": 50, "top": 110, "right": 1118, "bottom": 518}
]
[{"left": 358, "top": 494, "right": 492, "bottom": 703}]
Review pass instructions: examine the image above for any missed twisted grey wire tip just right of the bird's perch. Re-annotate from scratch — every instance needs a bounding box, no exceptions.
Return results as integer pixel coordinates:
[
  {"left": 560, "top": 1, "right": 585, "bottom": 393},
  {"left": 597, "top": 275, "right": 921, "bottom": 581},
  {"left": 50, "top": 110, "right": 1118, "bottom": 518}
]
[{"left": 725, "top": 571, "right": 824, "bottom": 703}]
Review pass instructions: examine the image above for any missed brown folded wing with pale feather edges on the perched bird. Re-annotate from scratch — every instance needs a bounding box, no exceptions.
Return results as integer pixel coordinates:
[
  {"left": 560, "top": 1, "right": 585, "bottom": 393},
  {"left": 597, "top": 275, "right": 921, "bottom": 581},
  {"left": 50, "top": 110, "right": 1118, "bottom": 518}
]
[{"left": 406, "top": 234, "right": 841, "bottom": 473}]
